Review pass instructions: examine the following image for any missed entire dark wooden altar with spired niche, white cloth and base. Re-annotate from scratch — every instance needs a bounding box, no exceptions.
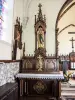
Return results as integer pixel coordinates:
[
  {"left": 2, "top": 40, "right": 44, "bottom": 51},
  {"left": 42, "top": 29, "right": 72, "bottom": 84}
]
[{"left": 17, "top": 4, "right": 61, "bottom": 98}]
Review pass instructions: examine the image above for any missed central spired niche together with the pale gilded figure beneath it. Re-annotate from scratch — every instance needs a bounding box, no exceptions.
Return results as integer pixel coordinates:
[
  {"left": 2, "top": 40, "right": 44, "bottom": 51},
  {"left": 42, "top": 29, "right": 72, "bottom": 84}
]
[{"left": 34, "top": 4, "right": 46, "bottom": 71}]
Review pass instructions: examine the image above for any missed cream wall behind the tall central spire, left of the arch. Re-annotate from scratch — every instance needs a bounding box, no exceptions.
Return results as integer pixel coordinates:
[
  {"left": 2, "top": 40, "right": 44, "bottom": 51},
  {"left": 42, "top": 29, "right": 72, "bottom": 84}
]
[{"left": 22, "top": 0, "right": 66, "bottom": 54}]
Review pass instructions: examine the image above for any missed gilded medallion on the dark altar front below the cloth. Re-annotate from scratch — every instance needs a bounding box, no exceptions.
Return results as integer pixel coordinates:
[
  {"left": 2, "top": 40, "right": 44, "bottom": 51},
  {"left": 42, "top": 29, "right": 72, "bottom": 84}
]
[{"left": 33, "top": 81, "right": 47, "bottom": 94}]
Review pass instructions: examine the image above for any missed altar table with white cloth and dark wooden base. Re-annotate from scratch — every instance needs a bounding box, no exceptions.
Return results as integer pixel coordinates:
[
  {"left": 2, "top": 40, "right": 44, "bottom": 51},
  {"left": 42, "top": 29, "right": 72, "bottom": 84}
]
[{"left": 15, "top": 72, "right": 64, "bottom": 98}]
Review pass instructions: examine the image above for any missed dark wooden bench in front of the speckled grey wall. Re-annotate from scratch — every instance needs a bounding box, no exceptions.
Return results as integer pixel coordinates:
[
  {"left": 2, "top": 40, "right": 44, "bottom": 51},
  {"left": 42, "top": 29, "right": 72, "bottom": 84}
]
[{"left": 0, "top": 83, "right": 18, "bottom": 100}]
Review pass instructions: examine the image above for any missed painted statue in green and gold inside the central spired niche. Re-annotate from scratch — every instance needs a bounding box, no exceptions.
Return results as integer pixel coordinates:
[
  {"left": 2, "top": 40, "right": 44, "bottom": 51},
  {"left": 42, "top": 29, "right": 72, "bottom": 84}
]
[{"left": 37, "top": 26, "right": 44, "bottom": 48}]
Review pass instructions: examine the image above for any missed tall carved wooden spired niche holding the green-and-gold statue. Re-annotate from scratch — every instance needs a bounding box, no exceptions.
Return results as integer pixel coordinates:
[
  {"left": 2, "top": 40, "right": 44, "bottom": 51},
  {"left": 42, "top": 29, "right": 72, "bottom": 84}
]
[{"left": 34, "top": 4, "right": 46, "bottom": 56}]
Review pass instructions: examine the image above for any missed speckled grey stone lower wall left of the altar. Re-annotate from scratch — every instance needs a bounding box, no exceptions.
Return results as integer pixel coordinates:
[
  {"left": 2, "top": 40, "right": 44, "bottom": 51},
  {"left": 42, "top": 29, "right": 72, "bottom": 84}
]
[{"left": 0, "top": 62, "right": 19, "bottom": 86}]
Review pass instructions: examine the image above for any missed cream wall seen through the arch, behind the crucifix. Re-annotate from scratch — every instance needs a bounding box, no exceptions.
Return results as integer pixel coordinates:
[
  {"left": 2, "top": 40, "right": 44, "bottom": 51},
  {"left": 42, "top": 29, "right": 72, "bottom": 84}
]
[{"left": 57, "top": 0, "right": 75, "bottom": 55}]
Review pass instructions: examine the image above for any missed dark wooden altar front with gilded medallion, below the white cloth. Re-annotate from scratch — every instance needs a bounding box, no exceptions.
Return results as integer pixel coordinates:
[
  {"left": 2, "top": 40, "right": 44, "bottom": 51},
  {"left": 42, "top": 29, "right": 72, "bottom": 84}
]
[{"left": 24, "top": 79, "right": 59, "bottom": 97}]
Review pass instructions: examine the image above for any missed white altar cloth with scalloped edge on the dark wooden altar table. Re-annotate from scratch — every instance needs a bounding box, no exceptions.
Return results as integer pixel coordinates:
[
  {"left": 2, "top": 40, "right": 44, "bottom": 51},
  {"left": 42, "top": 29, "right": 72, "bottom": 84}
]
[{"left": 16, "top": 73, "right": 64, "bottom": 80}]
